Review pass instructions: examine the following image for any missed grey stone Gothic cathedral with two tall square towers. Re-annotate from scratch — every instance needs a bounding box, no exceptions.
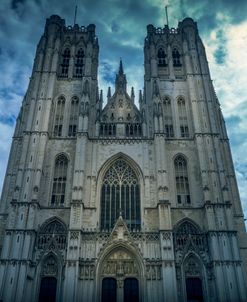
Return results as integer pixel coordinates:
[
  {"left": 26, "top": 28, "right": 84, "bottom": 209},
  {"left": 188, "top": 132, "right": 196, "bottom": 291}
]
[{"left": 0, "top": 15, "right": 247, "bottom": 302}]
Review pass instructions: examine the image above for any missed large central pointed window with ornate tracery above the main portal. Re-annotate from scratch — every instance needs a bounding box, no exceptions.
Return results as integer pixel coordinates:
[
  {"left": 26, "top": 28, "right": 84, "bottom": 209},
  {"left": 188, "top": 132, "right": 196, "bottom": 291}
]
[{"left": 101, "top": 159, "right": 141, "bottom": 230}]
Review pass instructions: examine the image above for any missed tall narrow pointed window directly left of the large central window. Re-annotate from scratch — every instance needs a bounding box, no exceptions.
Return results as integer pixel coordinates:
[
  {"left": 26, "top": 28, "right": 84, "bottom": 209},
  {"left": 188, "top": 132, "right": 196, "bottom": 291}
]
[{"left": 51, "top": 154, "right": 68, "bottom": 206}]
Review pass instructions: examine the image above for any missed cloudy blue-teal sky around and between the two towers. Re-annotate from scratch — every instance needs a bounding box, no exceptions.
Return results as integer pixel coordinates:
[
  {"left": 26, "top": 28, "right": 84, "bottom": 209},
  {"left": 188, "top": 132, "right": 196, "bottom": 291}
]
[{"left": 0, "top": 0, "right": 247, "bottom": 222}]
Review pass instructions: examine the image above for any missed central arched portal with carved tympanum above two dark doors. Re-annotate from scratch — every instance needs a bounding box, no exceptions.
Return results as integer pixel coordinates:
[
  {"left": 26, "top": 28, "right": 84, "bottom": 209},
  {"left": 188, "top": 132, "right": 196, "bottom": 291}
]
[{"left": 100, "top": 247, "right": 140, "bottom": 302}]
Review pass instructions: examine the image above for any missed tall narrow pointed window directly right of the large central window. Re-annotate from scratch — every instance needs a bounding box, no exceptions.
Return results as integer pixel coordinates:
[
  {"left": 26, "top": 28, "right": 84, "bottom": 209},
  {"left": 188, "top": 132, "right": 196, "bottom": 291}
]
[{"left": 174, "top": 155, "right": 191, "bottom": 205}]
